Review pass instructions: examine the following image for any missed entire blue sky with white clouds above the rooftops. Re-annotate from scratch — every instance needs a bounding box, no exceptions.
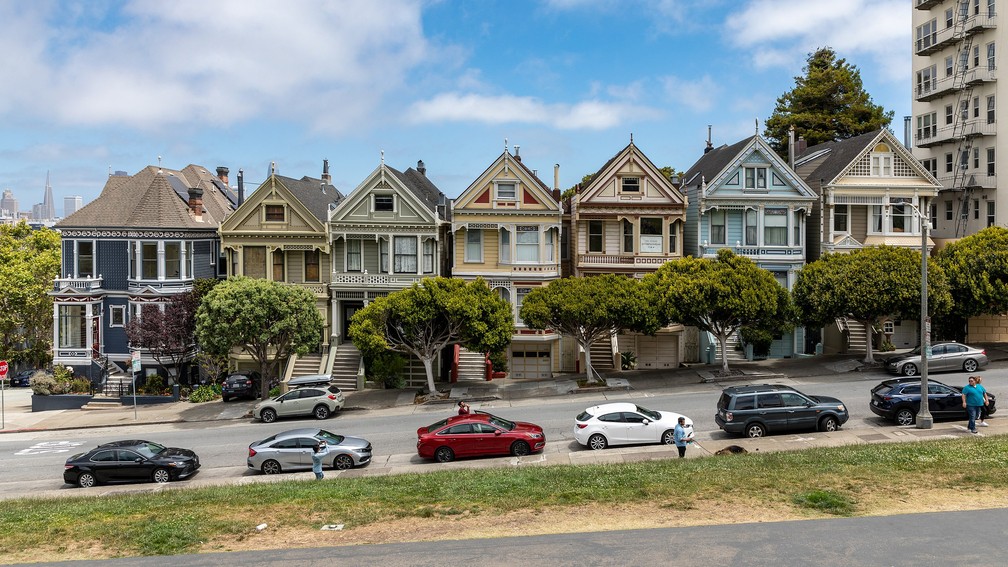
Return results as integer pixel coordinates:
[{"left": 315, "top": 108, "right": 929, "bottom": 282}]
[{"left": 0, "top": 0, "right": 912, "bottom": 214}]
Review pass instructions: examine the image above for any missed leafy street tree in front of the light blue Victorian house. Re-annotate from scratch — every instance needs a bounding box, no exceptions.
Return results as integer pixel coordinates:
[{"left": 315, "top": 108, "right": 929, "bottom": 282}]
[{"left": 644, "top": 248, "right": 791, "bottom": 373}]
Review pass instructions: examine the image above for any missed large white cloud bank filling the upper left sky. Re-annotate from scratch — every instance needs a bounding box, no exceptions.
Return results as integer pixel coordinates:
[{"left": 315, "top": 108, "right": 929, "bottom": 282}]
[{"left": 0, "top": 0, "right": 431, "bottom": 129}]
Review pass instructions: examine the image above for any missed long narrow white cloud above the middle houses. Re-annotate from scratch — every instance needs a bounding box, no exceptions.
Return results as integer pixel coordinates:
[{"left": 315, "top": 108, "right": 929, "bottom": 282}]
[{"left": 409, "top": 93, "right": 657, "bottom": 130}]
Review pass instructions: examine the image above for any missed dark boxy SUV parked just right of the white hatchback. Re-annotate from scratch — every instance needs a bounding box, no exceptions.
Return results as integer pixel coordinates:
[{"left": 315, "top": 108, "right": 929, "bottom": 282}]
[{"left": 714, "top": 384, "right": 850, "bottom": 438}]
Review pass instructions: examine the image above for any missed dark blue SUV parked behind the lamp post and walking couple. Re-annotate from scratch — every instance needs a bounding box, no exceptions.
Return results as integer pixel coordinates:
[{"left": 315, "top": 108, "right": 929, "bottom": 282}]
[{"left": 868, "top": 377, "right": 997, "bottom": 426}]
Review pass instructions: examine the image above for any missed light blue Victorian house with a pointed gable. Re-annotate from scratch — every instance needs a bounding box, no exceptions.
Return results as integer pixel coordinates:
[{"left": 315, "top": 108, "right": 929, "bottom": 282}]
[{"left": 681, "top": 135, "right": 817, "bottom": 357}]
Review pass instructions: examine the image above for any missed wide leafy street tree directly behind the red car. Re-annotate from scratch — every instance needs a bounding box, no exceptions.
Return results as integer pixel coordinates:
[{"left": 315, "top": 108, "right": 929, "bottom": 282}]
[{"left": 349, "top": 277, "right": 514, "bottom": 393}]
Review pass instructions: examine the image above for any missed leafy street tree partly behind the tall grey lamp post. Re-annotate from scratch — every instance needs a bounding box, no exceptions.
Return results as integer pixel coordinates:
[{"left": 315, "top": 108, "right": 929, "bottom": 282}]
[{"left": 791, "top": 246, "right": 952, "bottom": 363}]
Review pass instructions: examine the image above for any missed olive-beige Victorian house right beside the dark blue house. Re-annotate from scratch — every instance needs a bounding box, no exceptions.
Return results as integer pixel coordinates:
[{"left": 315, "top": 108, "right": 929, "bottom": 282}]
[{"left": 220, "top": 161, "right": 342, "bottom": 387}]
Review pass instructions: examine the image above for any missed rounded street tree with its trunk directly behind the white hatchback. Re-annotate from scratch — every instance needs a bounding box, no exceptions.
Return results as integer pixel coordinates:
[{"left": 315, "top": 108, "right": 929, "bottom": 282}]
[{"left": 521, "top": 273, "right": 645, "bottom": 381}]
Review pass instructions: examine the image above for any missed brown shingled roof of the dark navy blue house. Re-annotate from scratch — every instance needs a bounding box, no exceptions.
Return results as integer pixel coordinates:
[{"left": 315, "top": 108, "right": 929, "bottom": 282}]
[{"left": 54, "top": 164, "right": 237, "bottom": 229}]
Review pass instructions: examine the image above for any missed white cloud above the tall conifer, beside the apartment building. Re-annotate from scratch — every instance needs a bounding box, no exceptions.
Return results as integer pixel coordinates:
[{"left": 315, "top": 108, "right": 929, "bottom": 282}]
[{"left": 725, "top": 0, "right": 913, "bottom": 83}]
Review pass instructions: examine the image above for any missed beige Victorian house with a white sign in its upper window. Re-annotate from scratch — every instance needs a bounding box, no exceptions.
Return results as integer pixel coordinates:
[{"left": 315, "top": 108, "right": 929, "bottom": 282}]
[{"left": 570, "top": 138, "right": 697, "bottom": 369}]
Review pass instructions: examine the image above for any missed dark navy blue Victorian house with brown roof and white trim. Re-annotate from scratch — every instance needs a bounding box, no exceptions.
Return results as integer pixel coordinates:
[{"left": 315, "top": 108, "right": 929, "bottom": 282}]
[{"left": 50, "top": 165, "right": 238, "bottom": 380}]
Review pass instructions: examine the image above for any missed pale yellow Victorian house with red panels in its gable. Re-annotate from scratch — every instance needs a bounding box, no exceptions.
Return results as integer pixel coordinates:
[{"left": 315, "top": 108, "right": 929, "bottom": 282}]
[{"left": 452, "top": 146, "right": 562, "bottom": 378}]
